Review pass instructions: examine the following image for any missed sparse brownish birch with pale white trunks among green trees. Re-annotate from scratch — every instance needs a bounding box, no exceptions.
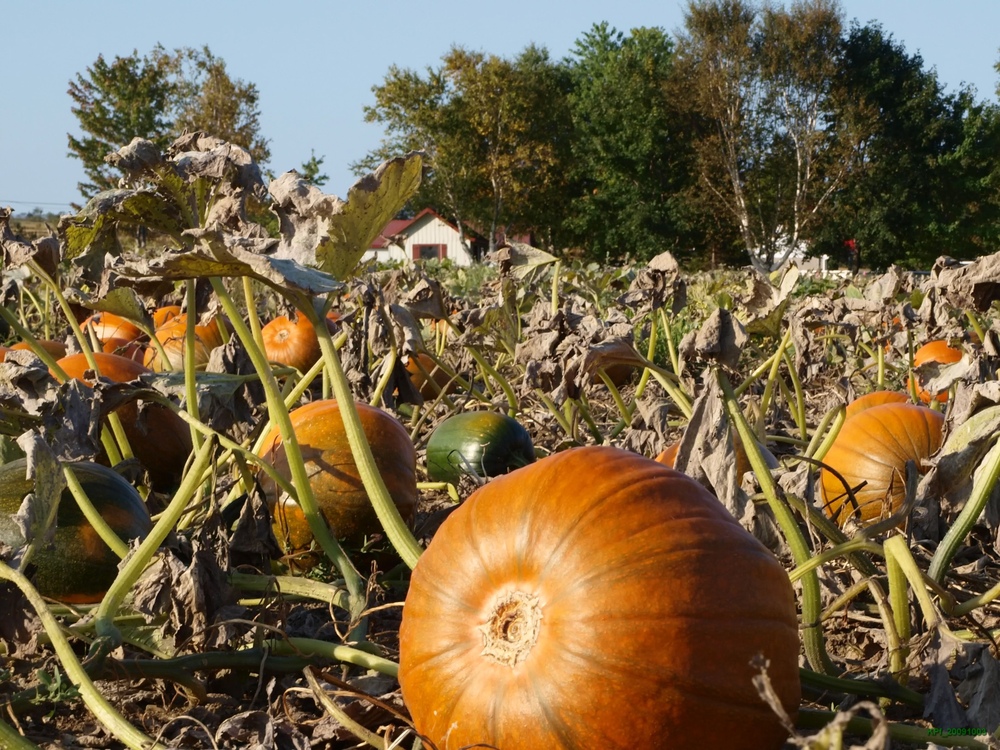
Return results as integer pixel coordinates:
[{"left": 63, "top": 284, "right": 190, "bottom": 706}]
[{"left": 671, "top": 0, "right": 857, "bottom": 271}]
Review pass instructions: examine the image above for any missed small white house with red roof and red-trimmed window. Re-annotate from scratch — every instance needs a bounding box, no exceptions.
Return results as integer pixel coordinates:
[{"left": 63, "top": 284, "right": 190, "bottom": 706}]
[{"left": 363, "top": 208, "right": 482, "bottom": 266}]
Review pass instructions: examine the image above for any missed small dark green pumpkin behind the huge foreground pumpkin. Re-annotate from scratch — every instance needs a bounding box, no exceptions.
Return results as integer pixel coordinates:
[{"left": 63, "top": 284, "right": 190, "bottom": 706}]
[{"left": 427, "top": 411, "right": 535, "bottom": 482}]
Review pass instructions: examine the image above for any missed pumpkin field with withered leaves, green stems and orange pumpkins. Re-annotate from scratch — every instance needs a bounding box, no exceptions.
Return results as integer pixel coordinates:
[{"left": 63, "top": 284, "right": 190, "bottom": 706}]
[{"left": 0, "top": 133, "right": 1000, "bottom": 750}]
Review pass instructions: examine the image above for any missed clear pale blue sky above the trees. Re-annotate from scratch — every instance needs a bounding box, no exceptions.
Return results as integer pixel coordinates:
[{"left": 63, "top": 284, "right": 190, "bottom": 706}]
[{"left": 0, "top": 0, "right": 1000, "bottom": 211}]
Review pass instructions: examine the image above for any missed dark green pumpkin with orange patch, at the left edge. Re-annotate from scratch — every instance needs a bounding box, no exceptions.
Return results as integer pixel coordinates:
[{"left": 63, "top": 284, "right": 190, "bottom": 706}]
[{"left": 0, "top": 458, "right": 152, "bottom": 604}]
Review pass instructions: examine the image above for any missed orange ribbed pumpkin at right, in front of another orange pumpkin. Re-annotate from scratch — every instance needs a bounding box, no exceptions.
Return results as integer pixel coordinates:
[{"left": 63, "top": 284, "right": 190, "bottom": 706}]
[{"left": 820, "top": 403, "right": 944, "bottom": 525}]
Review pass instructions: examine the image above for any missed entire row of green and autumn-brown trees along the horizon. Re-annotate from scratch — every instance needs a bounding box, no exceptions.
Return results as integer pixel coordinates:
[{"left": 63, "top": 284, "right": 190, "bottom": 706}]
[{"left": 70, "top": 0, "right": 1000, "bottom": 270}]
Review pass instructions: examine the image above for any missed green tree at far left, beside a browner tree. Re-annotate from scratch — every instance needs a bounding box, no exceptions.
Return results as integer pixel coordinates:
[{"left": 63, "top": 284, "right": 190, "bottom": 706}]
[{"left": 68, "top": 47, "right": 175, "bottom": 197}]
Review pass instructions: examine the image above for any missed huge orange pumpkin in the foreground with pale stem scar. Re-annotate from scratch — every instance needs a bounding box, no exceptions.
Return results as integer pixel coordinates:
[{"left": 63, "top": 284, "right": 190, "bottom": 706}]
[{"left": 399, "top": 447, "right": 800, "bottom": 750}]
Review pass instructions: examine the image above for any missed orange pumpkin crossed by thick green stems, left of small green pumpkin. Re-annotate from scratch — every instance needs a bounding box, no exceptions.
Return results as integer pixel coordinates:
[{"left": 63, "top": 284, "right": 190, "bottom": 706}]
[{"left": 260, "top": 399, "right": 417, "bottom": 551}]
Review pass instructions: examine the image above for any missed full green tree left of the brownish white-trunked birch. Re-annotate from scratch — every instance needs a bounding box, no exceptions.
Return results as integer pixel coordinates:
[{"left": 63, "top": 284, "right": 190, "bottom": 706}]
[{"left": 566, "top": 23, "right": 692, "bottom": 259}]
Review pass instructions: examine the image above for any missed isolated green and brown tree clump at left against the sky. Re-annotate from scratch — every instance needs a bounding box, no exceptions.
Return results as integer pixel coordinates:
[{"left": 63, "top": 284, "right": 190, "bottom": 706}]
[{"left": 67, "top": 45, "right": 270, "bottom": 198}]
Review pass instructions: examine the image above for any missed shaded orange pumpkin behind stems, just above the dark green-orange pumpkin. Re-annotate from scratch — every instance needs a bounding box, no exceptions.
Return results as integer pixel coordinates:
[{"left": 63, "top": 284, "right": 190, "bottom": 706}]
[{"left": 57, "top": 352, "right": 192, "bottom": 490}]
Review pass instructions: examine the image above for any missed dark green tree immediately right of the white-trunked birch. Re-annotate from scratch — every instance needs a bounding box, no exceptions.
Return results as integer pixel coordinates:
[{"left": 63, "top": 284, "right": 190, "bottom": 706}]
[{"left": 815, "top": 24, "right": 980, "bottom": 268}]
